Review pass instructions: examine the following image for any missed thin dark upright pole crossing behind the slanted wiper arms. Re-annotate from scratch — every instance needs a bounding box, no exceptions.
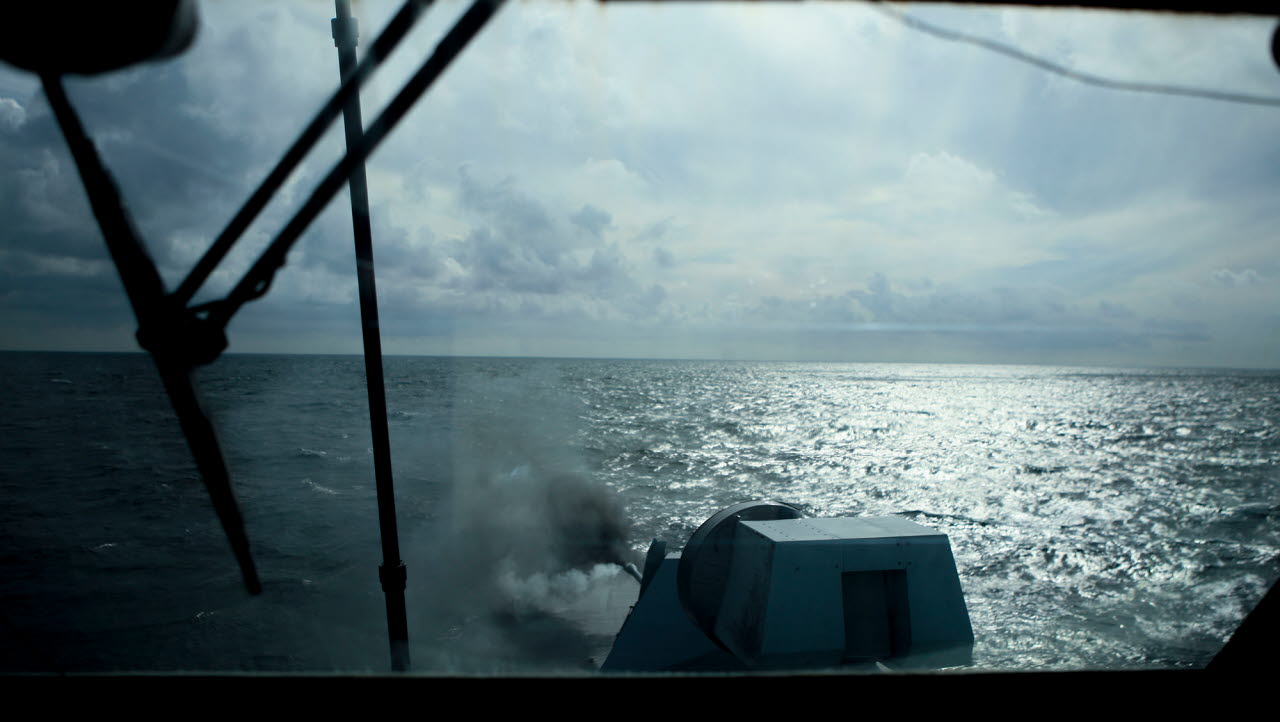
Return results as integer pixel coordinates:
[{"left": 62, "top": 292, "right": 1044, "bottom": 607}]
[{"left": 332, "top": 0, "right": 410, "bottom": 672}]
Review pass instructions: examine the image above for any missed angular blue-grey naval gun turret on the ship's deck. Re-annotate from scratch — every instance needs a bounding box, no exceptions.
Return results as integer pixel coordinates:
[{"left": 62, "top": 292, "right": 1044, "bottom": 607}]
[{"left": 602, "top": 502, "right": 974, "bottom": 672}]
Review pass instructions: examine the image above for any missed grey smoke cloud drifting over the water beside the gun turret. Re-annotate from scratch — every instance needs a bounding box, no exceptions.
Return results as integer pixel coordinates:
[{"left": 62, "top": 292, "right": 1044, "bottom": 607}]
[{"left": 396, "top": 366, "right": 637, "bottom": 673}]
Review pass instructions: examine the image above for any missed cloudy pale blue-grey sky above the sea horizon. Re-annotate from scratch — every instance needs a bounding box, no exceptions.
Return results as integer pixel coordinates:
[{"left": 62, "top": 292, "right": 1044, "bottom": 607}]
[{"left": 0, "top": 0, "right": 1280, "bottom": 369}]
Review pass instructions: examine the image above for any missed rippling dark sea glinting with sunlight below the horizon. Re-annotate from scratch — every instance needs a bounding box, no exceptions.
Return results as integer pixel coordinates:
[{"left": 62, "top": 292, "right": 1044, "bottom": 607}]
[{"left": 0, "top": 352, "right": 1280, "bottom": 675}]
